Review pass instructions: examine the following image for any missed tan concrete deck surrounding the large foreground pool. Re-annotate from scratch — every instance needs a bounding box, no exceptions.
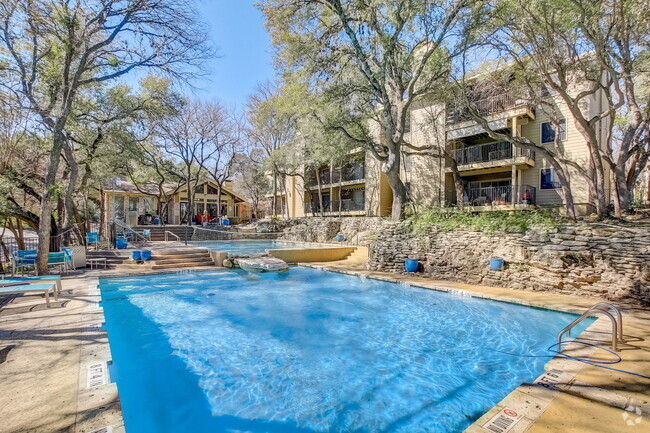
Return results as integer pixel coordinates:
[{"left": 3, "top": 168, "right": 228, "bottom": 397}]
[{"left": 0, "top": 255, "right": 650, "bottom": 433}]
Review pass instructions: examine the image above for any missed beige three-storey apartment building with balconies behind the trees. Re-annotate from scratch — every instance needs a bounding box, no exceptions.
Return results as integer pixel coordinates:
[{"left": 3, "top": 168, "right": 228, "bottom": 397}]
[{"left": 268, "top": 74, "right": 610, "bottom": 217}]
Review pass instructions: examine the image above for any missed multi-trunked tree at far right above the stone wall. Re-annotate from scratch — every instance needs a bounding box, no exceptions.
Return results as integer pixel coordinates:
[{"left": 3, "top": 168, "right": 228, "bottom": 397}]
[{"left": 476, "top": 0, "right": 650, "bottom": 217}]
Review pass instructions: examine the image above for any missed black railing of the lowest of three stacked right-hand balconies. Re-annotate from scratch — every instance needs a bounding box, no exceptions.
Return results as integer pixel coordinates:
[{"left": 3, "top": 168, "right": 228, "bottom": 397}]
[{"left": 446, "top": 185, "right": 537, "bottom": 206}]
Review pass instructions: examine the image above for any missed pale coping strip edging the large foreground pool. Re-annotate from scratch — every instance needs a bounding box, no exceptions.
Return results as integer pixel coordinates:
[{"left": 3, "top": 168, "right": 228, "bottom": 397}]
[{"left": 81, "top": 263, "right": 645, "bottom": 433}]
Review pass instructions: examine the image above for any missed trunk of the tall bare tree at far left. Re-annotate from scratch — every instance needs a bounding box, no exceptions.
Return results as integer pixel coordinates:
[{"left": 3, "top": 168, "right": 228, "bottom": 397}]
[{"left": 36, "top": 130, "right": 65, "bottom": 275}]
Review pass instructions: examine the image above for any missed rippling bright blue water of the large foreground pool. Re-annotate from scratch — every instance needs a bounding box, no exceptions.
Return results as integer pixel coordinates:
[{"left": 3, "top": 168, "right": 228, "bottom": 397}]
[{"left": 100, "top": 268, "right": 587, "bottom": 433}]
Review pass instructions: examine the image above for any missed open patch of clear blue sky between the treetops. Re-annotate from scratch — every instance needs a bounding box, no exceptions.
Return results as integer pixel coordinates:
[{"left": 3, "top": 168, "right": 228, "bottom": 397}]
[{"left": 191, "top": 0, "right": 274, "bottom": 108}]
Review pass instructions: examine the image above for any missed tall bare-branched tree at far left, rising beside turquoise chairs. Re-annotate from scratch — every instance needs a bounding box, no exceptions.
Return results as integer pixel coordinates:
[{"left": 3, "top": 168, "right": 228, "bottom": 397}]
[{"left": 0, "top": 0, "right": 211, "bottom": 274}]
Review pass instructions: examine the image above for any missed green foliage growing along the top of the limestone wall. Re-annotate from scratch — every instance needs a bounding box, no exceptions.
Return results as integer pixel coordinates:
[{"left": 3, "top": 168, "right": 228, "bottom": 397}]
[{"left": 408, "top": 208, "right": 562, "bottom": 234}]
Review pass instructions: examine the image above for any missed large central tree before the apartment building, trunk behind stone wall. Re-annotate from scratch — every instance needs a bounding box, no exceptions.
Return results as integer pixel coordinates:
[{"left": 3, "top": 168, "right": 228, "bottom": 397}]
[{"left": 261, "top": 0, "right": 484, "bottom": 220}]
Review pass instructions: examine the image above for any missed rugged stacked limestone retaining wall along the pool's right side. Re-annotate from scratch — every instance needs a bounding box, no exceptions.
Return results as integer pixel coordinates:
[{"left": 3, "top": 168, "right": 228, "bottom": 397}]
[{"left": 368, "top": 223, "right": 650, "bottom": 304}]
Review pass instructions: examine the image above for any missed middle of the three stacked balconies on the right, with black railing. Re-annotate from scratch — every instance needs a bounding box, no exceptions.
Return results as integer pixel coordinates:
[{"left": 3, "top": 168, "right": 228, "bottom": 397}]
[{"left": 454, "top": 141, "right": 535, "bottom": 170}]
